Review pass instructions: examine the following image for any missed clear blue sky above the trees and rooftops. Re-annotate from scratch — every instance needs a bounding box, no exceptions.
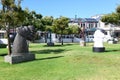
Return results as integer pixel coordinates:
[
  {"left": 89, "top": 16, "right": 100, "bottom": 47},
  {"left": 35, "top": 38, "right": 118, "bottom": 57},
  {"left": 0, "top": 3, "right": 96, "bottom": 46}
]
[{"left": 21, "top": 0, "right": 120, "bottom": 18}]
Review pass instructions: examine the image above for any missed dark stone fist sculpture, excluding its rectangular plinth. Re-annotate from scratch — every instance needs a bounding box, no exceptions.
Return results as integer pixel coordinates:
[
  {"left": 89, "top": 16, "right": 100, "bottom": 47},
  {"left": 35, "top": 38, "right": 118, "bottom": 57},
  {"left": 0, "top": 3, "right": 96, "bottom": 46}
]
[{"left": 12, "top": 26, "right": 35, "bottom": 55}]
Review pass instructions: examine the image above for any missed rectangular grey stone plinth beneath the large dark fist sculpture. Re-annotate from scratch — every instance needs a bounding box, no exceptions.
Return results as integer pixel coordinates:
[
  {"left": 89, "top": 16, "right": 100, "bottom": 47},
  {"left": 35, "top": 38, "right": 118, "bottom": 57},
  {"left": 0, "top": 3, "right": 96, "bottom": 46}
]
[{"left": 4, "top": 53, "right": 35, "bottom": 64}]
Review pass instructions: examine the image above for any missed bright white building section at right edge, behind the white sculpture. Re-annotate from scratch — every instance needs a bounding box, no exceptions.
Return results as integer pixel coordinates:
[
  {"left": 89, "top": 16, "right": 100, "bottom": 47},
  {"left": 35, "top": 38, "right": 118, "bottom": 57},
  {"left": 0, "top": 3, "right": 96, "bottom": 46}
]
[{"left": 92, "top": 15, "right": 120, "bottom": 42}]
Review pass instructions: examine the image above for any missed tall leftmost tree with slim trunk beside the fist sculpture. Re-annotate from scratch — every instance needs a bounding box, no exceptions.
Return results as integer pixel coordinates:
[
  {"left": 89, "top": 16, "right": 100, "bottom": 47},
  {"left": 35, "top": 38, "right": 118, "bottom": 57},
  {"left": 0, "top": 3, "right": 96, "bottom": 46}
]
[{"left": 0, "top": 0, "right": 24, "bottom": 55}]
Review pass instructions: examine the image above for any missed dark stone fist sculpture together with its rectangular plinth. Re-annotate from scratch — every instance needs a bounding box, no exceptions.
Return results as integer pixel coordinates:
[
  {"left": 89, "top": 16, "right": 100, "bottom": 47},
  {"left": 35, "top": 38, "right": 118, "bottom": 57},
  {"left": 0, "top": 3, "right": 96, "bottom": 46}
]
[{"left": 5, "top": 26, "right": 35, "bottom": 64}]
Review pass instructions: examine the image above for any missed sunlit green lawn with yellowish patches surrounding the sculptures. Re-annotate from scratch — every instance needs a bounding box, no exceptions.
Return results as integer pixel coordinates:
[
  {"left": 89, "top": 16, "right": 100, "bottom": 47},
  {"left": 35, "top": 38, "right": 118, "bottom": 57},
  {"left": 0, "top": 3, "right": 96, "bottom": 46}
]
[{"left": 0, "top": 43, "right": 120, "bottom": 80}]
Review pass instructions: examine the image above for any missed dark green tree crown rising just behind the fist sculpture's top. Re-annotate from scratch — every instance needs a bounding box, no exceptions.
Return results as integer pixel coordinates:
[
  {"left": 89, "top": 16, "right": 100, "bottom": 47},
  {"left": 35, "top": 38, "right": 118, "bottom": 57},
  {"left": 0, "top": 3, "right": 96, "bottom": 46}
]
[{"left": 23, "top": 8, "right": 45, "bottom": 30}]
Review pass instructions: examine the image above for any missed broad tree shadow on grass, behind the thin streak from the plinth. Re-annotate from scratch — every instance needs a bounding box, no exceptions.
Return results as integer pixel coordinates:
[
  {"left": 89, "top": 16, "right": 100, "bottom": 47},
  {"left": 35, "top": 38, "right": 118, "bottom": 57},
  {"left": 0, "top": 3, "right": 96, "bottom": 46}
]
[{"left": 31, "top": 49, "right": 65, "bottom": 54}]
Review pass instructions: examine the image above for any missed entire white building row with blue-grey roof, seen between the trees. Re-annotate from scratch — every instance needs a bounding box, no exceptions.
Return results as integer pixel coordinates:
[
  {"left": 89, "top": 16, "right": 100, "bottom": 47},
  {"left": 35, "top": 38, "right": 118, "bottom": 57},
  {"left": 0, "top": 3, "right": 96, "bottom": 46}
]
[{"left": 36, "top": 15, "right": 120, "bottom": 42}]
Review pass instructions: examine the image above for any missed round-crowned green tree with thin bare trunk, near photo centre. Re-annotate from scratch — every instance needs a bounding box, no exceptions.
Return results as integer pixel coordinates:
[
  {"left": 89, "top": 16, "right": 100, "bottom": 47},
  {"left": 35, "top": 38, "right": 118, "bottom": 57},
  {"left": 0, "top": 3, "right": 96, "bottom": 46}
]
[{"left": 53, "top": 16, "right": 69, "bottom": 45}]
